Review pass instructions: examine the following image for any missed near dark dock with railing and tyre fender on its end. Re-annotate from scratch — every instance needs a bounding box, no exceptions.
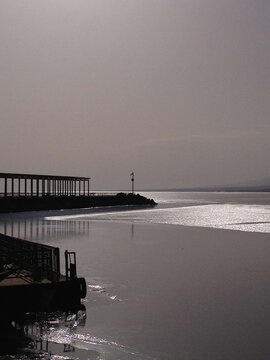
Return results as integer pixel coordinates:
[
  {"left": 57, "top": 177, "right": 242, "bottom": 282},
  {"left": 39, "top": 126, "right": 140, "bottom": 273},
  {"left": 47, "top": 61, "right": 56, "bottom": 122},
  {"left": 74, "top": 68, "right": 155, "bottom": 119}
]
[{"left": 0, "top": 234, "right": 86, "bottom": 317}]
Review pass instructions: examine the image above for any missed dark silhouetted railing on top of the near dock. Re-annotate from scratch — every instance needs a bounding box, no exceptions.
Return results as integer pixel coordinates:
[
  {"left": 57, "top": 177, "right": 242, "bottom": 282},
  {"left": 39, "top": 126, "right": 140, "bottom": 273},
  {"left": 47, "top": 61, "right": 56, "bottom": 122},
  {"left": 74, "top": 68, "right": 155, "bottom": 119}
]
[{"left": 0, "top": 234, "right": 60, "bottom": 281}]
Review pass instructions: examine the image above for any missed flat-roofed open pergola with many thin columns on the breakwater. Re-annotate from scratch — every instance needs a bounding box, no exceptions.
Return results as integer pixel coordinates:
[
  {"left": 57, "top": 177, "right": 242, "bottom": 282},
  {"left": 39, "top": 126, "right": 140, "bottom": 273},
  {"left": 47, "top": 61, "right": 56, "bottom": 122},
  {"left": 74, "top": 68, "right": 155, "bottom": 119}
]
[{"left": 0, "top": 173, "right": 91, "bottom": 197}]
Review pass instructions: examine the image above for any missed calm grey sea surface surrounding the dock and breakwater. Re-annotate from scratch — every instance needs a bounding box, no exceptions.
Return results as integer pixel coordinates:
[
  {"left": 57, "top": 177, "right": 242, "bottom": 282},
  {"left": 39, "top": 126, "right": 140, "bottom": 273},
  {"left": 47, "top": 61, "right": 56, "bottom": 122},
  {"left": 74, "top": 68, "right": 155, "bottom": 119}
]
[{"left": 0, "top": 193, "right": 270, "bottom": 360}]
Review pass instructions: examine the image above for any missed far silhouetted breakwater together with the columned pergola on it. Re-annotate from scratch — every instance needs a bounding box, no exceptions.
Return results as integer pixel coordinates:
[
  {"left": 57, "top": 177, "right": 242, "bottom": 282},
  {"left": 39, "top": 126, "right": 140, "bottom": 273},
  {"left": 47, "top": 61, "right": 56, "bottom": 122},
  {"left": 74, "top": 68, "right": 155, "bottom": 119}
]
[{"left": 0, "top": 173, "right": 155, "bottom": 213}]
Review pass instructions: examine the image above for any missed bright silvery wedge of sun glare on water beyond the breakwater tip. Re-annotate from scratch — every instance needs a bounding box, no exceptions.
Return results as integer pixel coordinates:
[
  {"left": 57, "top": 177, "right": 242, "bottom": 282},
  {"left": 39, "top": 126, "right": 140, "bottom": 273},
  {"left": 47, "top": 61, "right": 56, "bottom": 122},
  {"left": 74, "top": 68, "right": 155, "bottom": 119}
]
[{"left": 47, "top": 204, "right": 270, "bottom": 233}]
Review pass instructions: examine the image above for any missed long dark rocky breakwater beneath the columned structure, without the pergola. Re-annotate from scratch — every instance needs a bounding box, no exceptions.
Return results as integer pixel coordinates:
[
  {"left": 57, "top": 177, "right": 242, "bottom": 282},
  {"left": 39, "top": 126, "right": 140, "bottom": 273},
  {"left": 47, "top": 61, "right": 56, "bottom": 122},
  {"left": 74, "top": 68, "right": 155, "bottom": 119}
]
[{"left": 0, "top": 193, "right": 156, "bottom": 213}]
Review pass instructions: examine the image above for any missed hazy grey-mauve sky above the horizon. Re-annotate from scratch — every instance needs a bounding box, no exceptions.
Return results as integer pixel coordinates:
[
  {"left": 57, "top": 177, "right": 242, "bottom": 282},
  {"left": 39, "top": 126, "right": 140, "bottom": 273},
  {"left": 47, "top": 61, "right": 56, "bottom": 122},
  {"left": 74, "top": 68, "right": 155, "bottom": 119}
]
[{"left": 0, "top": 0, "right": 270, "bottom": 190}]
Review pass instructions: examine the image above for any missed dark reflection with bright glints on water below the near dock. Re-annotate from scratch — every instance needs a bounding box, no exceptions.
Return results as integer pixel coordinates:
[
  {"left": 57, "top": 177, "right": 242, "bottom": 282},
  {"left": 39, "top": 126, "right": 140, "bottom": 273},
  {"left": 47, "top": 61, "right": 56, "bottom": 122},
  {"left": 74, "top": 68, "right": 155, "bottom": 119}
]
[{"left": 0, "top": 308, "right": 151, "bottom": 360}]
